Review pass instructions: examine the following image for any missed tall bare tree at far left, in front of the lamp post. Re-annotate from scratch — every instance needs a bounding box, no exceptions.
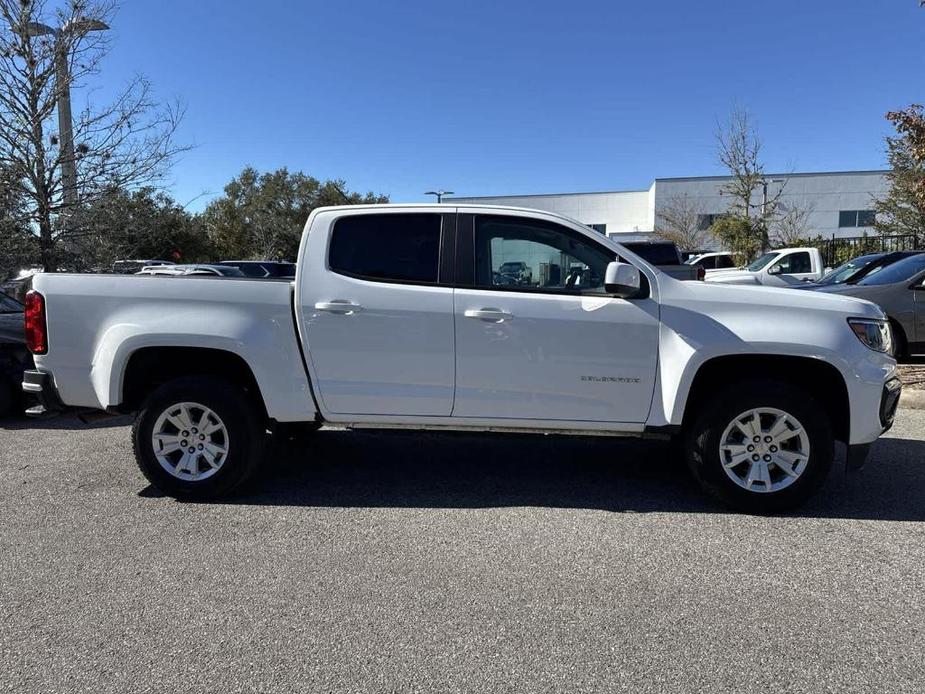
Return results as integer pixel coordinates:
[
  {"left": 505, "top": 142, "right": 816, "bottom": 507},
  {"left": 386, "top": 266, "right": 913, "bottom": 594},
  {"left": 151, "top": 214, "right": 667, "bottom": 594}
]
[{"left": 0, "top": 0, "right": 187, "bottom": 271}]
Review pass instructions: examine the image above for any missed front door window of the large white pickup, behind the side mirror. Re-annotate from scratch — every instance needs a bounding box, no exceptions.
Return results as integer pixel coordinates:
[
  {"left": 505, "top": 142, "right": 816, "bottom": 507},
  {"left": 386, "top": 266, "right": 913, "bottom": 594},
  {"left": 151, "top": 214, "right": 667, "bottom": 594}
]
[{"left": 475, "top": 217, "right": 616, "bottom": 294}]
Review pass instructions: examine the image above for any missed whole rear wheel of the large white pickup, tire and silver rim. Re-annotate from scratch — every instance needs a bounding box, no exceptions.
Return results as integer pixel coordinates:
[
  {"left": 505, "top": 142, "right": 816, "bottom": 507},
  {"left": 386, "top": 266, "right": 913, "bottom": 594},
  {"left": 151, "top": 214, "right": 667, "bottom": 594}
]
[{"left": 132, "top": 377, "right": 266, "bottom": 499}]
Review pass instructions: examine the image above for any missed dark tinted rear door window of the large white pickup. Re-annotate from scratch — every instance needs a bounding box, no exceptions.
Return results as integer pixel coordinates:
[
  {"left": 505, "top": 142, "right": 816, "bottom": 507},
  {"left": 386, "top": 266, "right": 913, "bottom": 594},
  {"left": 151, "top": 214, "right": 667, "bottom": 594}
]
[{"left": 328, "top": 213, "right": 441, "bottom": 284}]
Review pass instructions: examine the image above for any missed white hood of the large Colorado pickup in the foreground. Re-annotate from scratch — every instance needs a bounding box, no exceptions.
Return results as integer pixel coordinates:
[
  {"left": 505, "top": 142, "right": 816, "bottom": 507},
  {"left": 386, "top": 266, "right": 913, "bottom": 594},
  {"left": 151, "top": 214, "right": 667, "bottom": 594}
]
[{"left": 659, "top": 273, "right": 885, "bottom": 320}]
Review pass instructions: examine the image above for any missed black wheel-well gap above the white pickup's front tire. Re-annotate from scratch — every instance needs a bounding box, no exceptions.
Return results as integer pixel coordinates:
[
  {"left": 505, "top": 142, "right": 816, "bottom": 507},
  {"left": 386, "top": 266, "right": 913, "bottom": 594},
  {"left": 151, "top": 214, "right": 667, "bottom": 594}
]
[{"left": 682, "top": 354, "right": 851, "bottom": 442}]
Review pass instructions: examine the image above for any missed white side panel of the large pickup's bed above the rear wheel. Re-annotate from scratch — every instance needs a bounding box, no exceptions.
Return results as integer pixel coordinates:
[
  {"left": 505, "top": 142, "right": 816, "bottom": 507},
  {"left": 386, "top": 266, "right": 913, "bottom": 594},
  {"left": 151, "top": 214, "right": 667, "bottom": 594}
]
[{"left": 34, "top": 274, "right": 315, "bottom": 421}]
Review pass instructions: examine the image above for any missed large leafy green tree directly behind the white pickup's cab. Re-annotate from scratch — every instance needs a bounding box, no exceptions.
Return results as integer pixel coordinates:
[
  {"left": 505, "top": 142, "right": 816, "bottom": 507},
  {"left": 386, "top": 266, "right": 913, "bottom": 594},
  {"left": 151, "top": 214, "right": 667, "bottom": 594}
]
[{"left": 203, "top": 167, "right": 389, "bottom": 260}]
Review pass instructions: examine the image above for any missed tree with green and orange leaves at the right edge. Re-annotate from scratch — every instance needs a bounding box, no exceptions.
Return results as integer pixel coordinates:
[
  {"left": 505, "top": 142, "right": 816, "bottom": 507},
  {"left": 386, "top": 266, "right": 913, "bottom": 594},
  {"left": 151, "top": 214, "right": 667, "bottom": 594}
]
[{"left": 874, "top": 104, "right": 925, "bottom": 241}]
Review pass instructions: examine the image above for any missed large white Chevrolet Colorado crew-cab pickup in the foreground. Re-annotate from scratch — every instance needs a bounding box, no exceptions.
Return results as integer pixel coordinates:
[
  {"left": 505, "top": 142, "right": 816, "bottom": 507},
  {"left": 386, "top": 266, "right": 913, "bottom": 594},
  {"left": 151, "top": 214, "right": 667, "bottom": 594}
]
[{"left": 23, "top": 205, "right": 900, "bottom": 512}]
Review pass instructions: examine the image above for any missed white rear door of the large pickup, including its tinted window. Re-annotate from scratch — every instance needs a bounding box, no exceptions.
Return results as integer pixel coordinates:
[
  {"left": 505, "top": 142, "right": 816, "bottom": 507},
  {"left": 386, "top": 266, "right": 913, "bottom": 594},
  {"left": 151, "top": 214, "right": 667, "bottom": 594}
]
[{"left": 299, "top": 208, "right": 455, "bottom": 416}]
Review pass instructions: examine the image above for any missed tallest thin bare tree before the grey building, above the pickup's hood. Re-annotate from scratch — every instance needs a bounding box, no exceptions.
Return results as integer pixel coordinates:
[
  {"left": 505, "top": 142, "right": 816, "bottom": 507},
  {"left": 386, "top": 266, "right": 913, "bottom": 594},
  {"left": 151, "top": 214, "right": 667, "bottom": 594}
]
[{"left": 716, "top": 107, "right": 784, "bottom": 247}]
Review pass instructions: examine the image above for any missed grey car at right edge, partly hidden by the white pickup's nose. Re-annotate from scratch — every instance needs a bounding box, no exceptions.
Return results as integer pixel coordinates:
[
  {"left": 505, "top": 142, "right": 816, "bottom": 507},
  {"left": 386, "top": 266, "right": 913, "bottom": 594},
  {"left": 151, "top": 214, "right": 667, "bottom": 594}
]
[{"left": 816, "top": 251, "right": 925, "bottom": 358}]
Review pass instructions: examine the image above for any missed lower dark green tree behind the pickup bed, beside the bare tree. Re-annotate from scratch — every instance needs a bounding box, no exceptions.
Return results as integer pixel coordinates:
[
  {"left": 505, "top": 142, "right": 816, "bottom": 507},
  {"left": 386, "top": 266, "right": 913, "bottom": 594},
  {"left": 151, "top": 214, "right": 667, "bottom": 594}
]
[{"left": 66, "top": 188, "right": 211, "bottom": 271}]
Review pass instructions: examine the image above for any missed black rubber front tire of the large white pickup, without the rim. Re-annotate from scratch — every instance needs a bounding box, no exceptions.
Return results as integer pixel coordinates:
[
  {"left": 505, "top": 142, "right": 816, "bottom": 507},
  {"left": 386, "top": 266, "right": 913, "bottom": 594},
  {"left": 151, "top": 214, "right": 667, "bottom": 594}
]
[{"left": 685, "top": 379, "right": 835, "bottom": 514}]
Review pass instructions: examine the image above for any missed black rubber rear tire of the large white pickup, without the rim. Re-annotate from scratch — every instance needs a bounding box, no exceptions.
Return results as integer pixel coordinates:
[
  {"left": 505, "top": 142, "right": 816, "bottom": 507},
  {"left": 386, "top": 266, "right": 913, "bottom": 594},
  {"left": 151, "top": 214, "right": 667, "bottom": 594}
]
[{"left": 132, "top": 376, "right": 266, "bottom": 500}]
